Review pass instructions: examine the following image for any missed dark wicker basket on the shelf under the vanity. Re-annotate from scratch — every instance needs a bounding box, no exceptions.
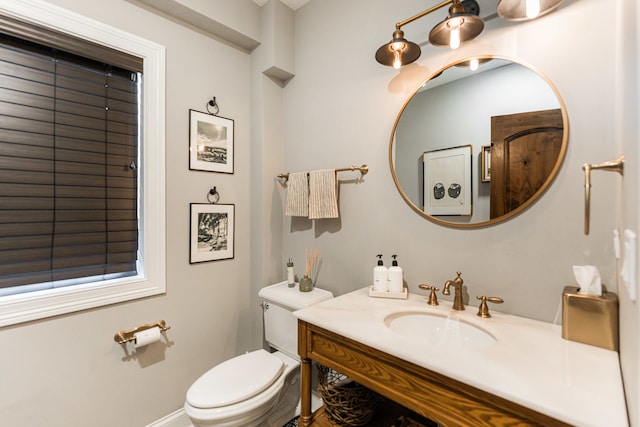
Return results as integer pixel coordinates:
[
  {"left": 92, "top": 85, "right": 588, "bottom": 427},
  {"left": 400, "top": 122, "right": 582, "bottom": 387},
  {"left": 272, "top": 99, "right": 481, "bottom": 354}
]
[{"left": 318, "top": 364, "right": 379, "bottom": 426}]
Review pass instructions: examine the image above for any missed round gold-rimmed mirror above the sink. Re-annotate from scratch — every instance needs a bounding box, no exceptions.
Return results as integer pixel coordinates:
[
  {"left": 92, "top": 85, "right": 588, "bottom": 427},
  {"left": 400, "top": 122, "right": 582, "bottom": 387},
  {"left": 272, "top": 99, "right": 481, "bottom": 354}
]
[{"left": 389, "top": 56, "right": 569, "bottom": 227}]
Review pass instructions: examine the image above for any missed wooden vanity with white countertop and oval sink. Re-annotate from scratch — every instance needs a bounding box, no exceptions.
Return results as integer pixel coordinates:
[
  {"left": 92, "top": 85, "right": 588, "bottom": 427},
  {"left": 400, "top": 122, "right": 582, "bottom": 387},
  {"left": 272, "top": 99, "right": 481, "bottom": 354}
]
[{"left": 294, "top": 288, "right": 628, "bottom": 427}]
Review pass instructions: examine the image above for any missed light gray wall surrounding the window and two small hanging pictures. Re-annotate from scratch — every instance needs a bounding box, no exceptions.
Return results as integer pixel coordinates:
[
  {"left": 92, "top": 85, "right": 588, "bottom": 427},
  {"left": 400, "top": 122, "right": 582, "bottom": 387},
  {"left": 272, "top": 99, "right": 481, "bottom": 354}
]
[{"left": 0, "top": 0, "right": 255, "bottom": 427}]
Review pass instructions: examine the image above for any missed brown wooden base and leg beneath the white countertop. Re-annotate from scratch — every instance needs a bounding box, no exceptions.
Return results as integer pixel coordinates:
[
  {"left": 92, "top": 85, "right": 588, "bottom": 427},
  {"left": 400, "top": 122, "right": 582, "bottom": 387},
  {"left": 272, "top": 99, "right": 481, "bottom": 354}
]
[{"left": 298, "top": 320, "right": 568, "bottom": 427}]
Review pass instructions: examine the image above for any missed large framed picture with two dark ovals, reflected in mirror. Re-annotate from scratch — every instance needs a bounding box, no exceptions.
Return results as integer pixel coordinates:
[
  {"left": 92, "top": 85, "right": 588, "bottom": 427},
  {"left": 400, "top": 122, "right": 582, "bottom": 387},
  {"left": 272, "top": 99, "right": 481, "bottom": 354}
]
[{"left": 422, "top": 145, "right": 472, "bottom": 215}]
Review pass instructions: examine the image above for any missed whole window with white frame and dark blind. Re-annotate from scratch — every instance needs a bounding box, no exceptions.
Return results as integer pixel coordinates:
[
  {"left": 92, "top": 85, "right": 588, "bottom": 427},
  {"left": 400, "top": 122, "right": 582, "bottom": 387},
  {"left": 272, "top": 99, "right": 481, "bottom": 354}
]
[{"left": 0, "top": 0, "right": 165, "bottom": 326}]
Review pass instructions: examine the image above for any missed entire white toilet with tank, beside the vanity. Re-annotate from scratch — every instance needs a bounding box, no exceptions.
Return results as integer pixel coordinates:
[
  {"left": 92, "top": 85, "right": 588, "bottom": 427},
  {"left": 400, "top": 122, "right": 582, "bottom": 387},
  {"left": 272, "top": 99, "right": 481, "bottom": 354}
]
[{"left": 184, "top": 281, "right": 333, "bottom": 427}]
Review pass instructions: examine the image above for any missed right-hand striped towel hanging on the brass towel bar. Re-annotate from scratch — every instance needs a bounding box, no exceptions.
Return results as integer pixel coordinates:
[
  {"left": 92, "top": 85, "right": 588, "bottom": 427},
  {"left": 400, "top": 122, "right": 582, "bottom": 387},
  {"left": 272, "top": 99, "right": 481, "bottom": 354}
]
[{"left": 309, "top": 169, "right": 340, "bottom": 219}]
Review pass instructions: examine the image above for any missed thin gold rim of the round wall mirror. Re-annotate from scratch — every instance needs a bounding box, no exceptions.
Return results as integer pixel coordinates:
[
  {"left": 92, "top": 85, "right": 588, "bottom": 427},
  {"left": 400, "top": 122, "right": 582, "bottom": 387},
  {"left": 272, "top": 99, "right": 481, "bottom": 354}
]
[{"left": 389, "top": 55, "right": 569, "bottom": 228}]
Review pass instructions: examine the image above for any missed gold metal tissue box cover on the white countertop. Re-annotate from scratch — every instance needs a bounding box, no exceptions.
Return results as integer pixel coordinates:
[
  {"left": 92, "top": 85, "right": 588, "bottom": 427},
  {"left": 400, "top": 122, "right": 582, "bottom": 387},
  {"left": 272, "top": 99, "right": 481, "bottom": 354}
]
[{"left": 562, "top": 286, "right": 618, "bottom": 351}]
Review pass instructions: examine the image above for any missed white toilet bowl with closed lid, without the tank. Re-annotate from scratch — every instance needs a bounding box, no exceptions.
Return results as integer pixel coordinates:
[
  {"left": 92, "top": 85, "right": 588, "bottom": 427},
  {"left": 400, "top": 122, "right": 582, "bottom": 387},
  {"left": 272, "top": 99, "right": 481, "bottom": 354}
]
[{"left": 184, "top": 350, "right": 300, "bottom": 427}]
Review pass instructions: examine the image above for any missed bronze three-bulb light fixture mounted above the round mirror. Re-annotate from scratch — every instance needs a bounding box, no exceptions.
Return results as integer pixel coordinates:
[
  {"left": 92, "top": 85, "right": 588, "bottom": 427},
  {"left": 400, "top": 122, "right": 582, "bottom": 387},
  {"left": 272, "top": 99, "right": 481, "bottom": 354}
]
[{"left": 376, "top": 0, "right": 563, "bottom": 69}]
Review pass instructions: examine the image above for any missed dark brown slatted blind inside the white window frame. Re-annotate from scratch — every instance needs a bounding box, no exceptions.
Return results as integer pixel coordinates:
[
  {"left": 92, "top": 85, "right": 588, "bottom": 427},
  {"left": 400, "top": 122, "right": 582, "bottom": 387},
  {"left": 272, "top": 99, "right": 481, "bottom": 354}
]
[{"left": 0, "top": 30, "right": 141, "bottom": 288}]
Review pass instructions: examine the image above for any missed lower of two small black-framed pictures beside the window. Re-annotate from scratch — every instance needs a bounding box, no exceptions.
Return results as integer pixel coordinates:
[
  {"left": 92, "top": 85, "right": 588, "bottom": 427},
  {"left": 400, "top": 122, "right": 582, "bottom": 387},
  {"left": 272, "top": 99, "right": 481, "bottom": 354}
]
[{"left": 189, "top": 203, "right": 235, "bottom": 264}]
